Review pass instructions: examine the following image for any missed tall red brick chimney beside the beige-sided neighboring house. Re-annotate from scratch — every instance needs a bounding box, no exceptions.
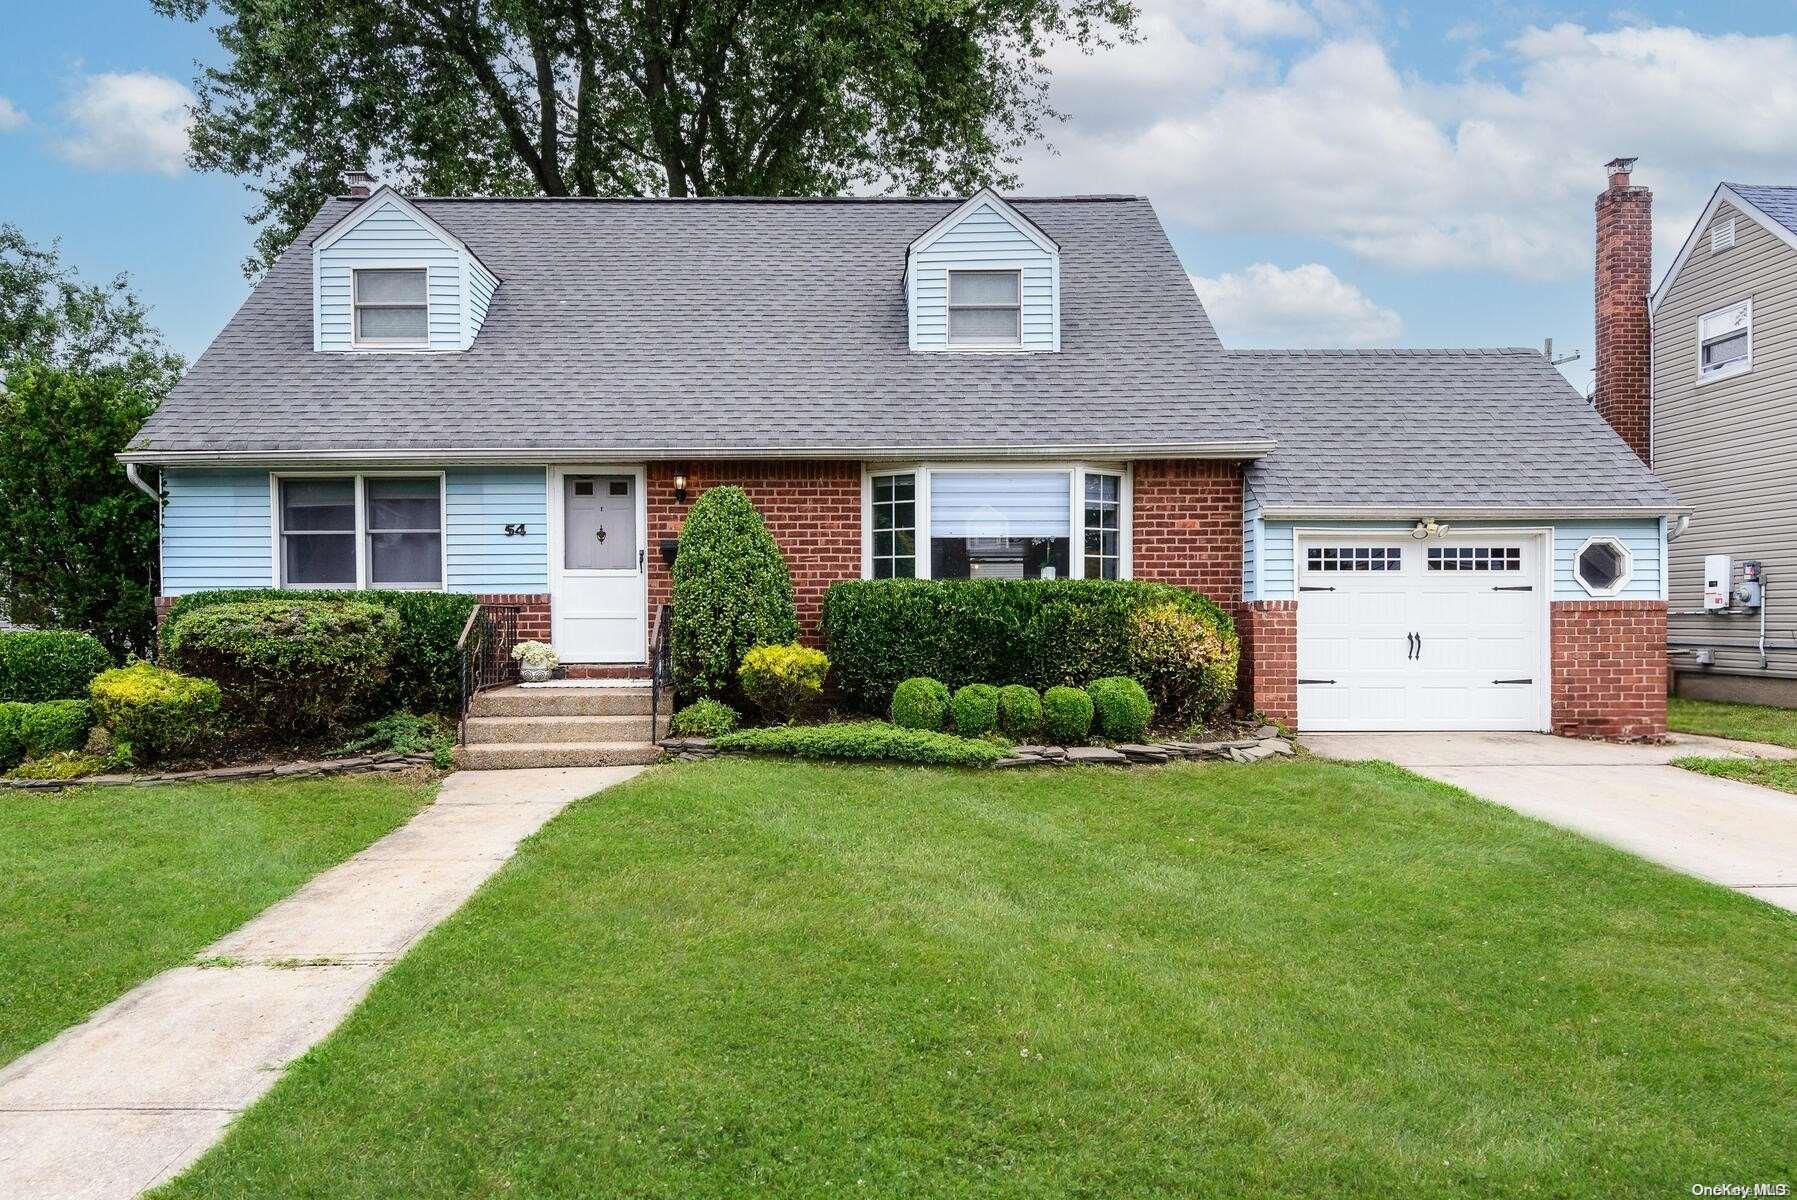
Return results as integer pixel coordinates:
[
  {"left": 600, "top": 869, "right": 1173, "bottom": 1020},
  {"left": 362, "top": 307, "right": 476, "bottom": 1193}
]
[{"left": 1598, "top": 158, "right": 1653, "bottom": 465}]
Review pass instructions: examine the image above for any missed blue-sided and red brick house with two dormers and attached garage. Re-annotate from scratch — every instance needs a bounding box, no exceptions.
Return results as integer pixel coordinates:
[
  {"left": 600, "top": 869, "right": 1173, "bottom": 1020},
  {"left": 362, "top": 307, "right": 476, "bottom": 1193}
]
[{"left": 124, "top": 177, "right": 1680, "bottom": 735}]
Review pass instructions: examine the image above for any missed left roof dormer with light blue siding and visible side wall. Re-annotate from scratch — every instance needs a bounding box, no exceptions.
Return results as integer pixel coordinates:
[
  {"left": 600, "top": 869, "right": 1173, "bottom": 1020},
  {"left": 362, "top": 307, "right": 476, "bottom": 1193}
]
[{"left": 313, "top": 187, "right": 500, "bottom": 352}]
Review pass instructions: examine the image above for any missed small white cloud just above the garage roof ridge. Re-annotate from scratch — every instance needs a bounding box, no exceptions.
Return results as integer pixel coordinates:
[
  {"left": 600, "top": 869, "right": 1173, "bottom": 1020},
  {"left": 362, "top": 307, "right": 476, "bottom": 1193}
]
[{"left": 1191, "top": 262, "right": 1403, "bottom": 347}]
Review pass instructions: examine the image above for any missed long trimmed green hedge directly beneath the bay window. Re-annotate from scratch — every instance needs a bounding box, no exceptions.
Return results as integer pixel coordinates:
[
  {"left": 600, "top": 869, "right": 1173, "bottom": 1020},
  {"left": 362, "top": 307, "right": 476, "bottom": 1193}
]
[{"left": 823, "top": 578, "right": 1240, "bottom": 715}]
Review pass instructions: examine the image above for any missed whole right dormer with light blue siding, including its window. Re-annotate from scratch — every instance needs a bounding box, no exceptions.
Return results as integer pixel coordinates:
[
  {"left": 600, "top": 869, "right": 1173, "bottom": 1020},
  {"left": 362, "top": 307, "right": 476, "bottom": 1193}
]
[{"left": 904, "top": 187, "right": 1060, "bottom": 354}]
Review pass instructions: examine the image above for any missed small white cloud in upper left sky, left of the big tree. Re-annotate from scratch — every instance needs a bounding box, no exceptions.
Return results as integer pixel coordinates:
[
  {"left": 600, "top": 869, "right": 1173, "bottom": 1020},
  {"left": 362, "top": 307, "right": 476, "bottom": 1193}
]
[{"left": 56, "top": 70, "right": 194, "bottom": 176}]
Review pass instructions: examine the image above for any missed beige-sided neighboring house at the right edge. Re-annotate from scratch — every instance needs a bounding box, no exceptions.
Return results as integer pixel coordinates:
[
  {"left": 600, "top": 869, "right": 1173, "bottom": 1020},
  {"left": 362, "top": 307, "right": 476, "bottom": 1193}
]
[{"left": 1638, "top": 160, "right": 1797, "bottom": 706}]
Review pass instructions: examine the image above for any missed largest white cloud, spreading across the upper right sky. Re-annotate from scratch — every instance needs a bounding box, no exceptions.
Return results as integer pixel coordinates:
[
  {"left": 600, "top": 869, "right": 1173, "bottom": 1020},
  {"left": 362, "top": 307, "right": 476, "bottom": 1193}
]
[{"left": 1022, "top": 15, "right": 1797, "bottom": 278}]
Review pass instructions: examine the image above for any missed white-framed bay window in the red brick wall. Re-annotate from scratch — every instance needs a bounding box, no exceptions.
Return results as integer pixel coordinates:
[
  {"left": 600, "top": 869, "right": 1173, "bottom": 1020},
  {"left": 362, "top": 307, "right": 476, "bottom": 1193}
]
[{"left": 864, "top": 465, "right": 1127, "bottom": 578}]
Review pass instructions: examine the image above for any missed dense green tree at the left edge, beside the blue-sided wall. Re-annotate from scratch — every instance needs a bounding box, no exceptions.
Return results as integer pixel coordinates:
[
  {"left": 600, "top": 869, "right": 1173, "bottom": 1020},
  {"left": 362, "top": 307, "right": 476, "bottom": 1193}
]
[{"left": 0, "top": 225, "right": 181, "bottom": 654}]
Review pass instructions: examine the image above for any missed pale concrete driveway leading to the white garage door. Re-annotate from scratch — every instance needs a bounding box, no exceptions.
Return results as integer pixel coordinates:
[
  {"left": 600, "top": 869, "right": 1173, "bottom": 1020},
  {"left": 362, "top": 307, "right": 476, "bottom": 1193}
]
[{"left": 1301, "top": 733, "right": 1797, "bottom": 913}]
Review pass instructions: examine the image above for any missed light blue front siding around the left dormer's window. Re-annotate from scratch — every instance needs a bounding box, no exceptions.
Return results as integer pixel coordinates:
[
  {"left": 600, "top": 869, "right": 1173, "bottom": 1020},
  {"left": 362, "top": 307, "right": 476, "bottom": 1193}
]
[{"left": 314, "top": 201, "right": 467, "bottom": 350}]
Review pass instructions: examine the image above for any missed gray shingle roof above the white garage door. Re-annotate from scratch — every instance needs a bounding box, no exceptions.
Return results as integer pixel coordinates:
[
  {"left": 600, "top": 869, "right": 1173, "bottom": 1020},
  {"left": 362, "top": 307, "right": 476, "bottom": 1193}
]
[{"left": 1224, "top": 350, "right": 1677, "bottom": 516}]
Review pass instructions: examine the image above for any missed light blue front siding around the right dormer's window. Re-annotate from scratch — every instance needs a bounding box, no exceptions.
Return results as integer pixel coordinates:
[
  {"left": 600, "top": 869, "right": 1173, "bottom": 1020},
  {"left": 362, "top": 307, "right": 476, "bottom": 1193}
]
[{"left": 909, "top": 205, "right": 1060, "bottom": 350}]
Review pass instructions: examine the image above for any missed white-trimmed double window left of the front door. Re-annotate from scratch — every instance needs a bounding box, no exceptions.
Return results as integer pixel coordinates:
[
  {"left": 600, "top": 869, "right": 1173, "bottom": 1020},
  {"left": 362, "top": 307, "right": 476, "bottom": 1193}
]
[{"left": 277, "top": 474, "right": 444, "bottom": 589}]
